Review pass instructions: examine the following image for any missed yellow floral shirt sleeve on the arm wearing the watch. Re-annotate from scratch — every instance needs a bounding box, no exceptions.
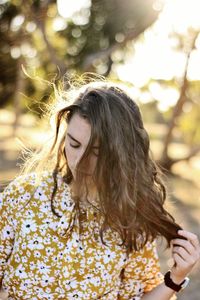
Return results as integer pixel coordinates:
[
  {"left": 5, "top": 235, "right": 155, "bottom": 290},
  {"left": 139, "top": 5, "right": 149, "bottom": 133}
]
[{"left": 118, "top": 241, "right": 176, "bottom": 300}]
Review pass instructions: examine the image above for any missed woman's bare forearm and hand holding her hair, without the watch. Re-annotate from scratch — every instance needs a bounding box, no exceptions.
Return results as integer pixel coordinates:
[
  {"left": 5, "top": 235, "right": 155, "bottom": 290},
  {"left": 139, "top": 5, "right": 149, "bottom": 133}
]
[{"left": 142, "top": 230, "right": 200, "bottom": 300}]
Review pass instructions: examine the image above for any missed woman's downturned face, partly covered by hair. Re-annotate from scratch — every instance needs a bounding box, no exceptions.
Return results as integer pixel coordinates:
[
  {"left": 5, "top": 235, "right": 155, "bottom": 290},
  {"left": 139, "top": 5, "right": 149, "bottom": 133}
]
[{"left": 65, "top": 113, "right": 98, "bottom": 178}]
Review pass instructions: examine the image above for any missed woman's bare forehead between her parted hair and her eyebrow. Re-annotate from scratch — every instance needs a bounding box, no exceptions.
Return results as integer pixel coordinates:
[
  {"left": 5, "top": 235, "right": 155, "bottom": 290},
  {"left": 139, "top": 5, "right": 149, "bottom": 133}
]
[{"left": 67, "top": 113, "right": 91, "bottom": 145}]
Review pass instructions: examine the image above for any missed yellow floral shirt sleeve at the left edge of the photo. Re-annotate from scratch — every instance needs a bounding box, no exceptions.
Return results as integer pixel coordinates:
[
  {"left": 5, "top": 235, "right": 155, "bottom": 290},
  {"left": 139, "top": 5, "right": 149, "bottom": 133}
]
[{"left": 0, "top": 175, "right": 37, "bottom": 286}]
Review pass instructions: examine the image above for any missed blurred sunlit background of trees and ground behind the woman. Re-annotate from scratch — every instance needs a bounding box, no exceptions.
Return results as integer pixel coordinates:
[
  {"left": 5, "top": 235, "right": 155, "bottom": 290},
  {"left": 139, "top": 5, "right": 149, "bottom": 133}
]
[{"left": 0, "top": 0, "right": 200, "bottom": 300}]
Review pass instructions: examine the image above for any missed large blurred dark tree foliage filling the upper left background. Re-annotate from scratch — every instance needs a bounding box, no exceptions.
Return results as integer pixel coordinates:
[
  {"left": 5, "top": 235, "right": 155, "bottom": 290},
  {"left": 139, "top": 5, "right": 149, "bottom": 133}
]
[{"left": 0, "top": 0, "right": 159, "bottom": 110}]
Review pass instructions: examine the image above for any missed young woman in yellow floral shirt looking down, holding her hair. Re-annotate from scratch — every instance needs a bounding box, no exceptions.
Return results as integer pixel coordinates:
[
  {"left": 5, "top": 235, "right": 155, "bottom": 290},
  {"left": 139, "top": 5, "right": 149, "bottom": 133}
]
[{"left": 0, "top": 78, "right": 200, "bottom": 300}]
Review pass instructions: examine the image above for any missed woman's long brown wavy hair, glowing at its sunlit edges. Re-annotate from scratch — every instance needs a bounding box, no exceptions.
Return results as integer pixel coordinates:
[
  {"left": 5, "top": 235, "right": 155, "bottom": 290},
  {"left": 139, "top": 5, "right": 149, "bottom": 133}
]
[{"left": 19, "top": 78, "right": 184, "bottom": 251}]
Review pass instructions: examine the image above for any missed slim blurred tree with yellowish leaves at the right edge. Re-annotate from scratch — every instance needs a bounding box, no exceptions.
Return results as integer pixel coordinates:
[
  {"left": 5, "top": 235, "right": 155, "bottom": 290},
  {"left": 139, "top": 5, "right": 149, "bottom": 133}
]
[{"left": 160, "top": 29, "right": 200, "bottom": 171}]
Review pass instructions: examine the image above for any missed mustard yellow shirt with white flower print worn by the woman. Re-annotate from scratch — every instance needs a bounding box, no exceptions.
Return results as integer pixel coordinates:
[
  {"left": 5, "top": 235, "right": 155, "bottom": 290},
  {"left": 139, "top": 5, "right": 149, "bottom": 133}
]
[{"left": 0, "top": 172, "right": 163, "bottom": 300}]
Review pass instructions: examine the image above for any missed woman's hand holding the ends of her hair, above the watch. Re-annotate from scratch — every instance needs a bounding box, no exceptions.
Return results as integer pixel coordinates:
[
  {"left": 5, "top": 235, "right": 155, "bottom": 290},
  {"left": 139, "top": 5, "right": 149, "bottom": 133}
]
[{"left": 171, "top": 230, "right": 200, "bottom": 284}]
